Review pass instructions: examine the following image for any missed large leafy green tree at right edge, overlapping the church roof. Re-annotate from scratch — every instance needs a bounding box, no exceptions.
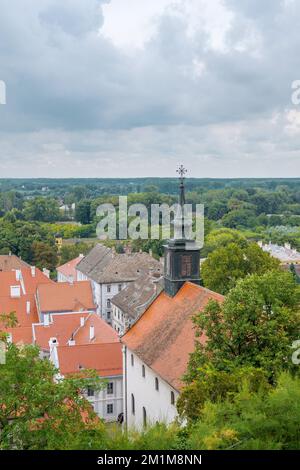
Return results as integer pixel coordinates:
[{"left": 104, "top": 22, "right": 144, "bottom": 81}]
[{"left": 177, "top": 271, "right": 300, "bottom": 421}]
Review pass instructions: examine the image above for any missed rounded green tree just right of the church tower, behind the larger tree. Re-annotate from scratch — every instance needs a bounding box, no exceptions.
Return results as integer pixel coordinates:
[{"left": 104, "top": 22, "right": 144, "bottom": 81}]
[{"left": 201, "top": 240, "right": 280, "bottom": 294}]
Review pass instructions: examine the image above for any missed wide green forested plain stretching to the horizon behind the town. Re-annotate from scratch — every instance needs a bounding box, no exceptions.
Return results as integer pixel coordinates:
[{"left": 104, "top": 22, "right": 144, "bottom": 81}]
[{"left": 0, "top": 177, "right": 300, "bottom": 274}]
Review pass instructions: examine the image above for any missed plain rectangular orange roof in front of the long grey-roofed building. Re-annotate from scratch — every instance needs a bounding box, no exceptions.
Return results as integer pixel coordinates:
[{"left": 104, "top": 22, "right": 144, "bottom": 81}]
[{"left": 37, "top": 281, "right": 96, "bottom": 313}]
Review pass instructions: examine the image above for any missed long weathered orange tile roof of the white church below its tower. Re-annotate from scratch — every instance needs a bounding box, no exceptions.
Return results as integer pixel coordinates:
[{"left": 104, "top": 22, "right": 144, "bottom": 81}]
[{"left": 121, "top": 282, "right": 224, "bottom": 390}]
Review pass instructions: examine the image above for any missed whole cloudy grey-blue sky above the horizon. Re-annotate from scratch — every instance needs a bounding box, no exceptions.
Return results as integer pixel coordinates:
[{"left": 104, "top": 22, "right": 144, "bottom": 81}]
[{"left": 0, "top": 0, "right": 300, "bottom": 178}]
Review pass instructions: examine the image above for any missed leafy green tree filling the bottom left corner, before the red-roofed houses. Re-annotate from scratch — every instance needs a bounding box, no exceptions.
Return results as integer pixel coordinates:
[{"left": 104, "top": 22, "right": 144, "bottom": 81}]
[{"left": 0, "top": 344, "right": 103, "bottom": 450}]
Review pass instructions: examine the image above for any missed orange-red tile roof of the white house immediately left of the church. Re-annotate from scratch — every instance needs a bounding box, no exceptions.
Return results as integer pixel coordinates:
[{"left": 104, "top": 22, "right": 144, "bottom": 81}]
[{"left": 57, "top": 343, "right": 123, "bottom": 377}]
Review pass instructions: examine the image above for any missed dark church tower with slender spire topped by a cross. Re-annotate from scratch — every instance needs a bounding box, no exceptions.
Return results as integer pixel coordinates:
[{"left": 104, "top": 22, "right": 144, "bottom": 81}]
[{"left": 164, "top": 165, "right": 200, "bottom": 297}]
